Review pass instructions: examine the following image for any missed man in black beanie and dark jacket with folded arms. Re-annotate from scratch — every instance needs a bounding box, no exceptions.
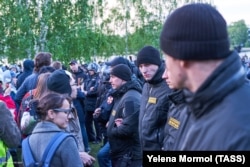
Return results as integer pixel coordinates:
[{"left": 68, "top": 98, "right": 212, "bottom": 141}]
[{"left": 107, "top": 64, "right": 142, "bottom": 167}]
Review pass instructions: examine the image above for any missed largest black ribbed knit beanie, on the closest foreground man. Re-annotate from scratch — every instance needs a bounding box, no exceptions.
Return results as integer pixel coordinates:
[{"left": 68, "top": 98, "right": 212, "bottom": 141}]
[{"left": 160, "top": 3, "right": 230, "bottom": 60}]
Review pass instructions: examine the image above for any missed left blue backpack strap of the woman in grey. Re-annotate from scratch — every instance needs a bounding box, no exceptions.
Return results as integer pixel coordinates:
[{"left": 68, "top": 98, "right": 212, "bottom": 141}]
[{"left": 22, "top": 136, "right": 35, "bottom": 167}]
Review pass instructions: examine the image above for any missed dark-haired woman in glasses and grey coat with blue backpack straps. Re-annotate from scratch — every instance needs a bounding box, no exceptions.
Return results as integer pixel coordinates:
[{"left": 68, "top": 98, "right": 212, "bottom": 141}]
[{"left": 22, "top": 93, "right": 83, "bottom": 167}]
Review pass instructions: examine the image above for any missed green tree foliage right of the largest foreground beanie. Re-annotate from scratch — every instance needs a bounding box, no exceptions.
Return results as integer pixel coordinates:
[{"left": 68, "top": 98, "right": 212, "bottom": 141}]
[{"left": 228, "top": 20, "right": 248, "bottom": 47}]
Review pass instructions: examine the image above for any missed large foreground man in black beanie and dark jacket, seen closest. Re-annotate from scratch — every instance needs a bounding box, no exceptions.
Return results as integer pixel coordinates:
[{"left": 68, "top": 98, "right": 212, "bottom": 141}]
[{"left": 160, "top": 3, "right": 250, "bottom": 150}]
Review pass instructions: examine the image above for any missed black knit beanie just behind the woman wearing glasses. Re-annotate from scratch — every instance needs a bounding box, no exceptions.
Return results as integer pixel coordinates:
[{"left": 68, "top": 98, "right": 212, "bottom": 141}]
[{"left": 47, "top": 70, "right": 72, "bottom": 95}]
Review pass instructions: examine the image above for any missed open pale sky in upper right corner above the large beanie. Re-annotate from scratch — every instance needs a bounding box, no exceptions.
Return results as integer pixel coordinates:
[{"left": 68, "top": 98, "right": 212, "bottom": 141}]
[{"left": 213, "top": 0, "right": 250, "bottom": 27}]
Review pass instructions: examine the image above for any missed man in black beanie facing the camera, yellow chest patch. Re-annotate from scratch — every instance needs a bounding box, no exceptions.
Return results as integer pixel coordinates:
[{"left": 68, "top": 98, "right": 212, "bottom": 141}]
[{"left": 136, "top": 46, "right": 172, "bottom": 151}]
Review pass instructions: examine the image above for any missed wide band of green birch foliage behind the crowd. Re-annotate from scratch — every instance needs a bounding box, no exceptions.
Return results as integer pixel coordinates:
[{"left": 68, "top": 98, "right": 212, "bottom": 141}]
[{"left": 0, "top": 0, "right": 211, "bottom": 63}]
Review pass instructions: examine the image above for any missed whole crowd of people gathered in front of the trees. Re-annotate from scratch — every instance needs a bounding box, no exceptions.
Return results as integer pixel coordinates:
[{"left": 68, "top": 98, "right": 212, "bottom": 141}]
[{"left": 0, "top": 3, "right": 250, "bottom": 167}]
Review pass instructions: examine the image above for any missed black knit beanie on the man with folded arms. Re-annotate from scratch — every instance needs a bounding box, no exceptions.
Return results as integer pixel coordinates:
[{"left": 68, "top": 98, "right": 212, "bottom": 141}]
[{"left": 110, "top": 64, "right": 132, "bottom": 81}]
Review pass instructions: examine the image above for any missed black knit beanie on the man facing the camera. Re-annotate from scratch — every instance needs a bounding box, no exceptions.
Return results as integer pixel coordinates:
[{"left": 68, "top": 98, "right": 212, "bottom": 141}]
[{"left": 136, "top": 46, "right": 161, "bottom": 66}]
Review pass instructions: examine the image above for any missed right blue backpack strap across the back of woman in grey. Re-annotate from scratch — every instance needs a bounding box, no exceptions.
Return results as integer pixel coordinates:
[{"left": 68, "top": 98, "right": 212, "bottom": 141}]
[{"left": 42, "top": 132, "right": 74, "bottom": 167}]
